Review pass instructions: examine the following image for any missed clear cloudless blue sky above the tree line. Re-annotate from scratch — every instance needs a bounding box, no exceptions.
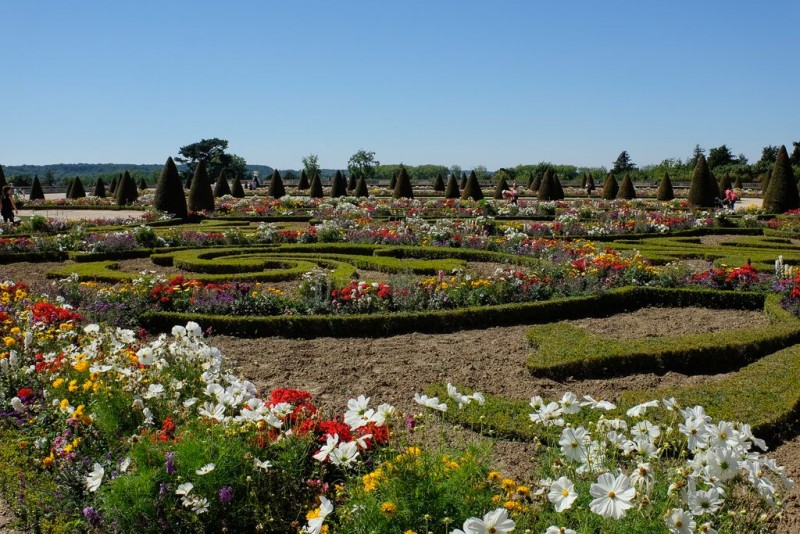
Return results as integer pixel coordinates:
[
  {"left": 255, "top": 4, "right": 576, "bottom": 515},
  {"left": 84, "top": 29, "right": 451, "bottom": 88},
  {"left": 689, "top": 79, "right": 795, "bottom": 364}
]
[{"left": 0, "top": 0, "right": 800, "bottom": 169}]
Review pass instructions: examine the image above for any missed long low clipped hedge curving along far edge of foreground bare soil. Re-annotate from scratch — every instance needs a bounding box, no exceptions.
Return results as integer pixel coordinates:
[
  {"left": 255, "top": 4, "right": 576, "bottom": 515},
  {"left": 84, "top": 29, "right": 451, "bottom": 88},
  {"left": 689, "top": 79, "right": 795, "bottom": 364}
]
[{"left": 139, "top": 287, "right": 763, "bottom": 339}]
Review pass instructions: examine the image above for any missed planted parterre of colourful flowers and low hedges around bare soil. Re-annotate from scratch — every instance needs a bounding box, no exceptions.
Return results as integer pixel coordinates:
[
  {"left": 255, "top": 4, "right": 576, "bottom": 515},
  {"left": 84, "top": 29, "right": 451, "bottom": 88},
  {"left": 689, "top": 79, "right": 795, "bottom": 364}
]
[{"left": 0, "top": 164, "right": 800, "bottom": 534}]
